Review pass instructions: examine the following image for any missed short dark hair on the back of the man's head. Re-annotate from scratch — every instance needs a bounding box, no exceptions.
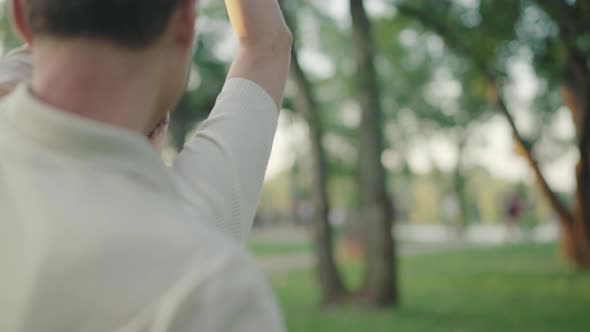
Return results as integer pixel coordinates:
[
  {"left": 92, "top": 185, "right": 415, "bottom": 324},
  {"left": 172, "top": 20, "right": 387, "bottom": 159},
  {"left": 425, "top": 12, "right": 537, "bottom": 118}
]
[{"left": 24, "top": 0, "right": 184, "bottom": 48}]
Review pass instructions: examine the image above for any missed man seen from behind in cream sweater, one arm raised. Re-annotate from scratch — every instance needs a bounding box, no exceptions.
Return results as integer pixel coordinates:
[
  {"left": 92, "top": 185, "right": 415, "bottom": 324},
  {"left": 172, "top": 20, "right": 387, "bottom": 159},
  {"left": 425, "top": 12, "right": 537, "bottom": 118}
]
[{"left": 0, "top": 0, "right": 291, "bottom": 332}]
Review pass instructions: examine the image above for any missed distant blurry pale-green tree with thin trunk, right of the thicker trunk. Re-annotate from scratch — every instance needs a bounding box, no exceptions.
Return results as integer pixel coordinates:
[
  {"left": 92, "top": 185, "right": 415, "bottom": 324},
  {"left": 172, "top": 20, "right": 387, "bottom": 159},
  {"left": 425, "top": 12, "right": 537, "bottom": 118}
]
[{"left": 374, "top": 11, "right": 493, "bottom": 230}]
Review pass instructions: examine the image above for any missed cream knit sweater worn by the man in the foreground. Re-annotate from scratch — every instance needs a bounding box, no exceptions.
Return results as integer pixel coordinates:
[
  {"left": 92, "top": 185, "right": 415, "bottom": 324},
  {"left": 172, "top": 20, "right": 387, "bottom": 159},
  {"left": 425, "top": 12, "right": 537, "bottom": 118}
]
[{"left": 0, "top": 79, "right": 283, "bottom": 332}]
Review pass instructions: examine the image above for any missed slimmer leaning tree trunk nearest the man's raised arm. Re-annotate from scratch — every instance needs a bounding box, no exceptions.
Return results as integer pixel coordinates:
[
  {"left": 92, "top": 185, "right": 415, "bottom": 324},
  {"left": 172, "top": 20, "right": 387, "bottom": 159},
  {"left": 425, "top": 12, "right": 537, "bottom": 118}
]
[{"left": 291, "top": 27, "right": 348, "bottom": 304}]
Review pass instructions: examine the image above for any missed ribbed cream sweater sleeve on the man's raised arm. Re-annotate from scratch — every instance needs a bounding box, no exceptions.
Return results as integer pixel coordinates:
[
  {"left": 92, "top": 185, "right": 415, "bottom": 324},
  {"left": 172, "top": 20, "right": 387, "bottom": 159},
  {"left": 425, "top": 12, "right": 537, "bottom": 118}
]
[{"left": 173, "top": 79, "right": 278, "bottom": 241}]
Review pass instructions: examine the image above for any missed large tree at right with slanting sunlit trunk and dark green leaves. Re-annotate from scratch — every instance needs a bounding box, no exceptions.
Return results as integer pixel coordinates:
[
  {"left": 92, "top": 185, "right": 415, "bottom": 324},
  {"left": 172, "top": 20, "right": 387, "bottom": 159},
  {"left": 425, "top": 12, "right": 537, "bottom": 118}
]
[{"left": 395, "top": 0, "right": 590, "bottom": 269}]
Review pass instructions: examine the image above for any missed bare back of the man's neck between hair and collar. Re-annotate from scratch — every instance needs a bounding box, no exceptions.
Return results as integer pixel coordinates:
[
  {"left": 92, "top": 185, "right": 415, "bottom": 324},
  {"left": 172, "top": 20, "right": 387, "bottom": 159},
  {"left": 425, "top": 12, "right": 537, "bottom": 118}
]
[{"left": 32, "top": 40, "right": 159, "bottom": 134}]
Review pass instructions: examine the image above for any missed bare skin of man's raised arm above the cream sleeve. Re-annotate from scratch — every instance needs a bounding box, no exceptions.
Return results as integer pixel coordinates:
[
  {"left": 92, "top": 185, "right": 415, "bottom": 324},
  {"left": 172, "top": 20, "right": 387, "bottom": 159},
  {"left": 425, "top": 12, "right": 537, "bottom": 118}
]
[{"left": 225, "top": 0, "right": 293, "bottom": 107}]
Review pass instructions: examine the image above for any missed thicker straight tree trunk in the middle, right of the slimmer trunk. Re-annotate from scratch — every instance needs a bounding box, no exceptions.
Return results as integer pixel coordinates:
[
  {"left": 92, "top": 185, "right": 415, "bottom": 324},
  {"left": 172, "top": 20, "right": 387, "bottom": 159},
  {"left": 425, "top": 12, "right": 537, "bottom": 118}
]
[{"left": 350, "top": 0, "right": 399, "bottom": 307}]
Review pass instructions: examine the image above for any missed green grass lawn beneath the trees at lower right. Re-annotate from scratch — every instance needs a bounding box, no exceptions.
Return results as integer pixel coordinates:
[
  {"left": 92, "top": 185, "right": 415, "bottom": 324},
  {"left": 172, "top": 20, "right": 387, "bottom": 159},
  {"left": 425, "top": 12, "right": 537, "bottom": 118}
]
[{"left": 273, "top": 245, "right": 590, "bottom": 332}]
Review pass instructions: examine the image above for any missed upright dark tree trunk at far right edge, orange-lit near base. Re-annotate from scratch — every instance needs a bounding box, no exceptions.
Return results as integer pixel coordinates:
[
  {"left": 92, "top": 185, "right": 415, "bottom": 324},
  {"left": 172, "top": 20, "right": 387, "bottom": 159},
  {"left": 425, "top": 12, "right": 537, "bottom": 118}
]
[{"left": 535, "top": 0, "right": 590, "bottom": 269}]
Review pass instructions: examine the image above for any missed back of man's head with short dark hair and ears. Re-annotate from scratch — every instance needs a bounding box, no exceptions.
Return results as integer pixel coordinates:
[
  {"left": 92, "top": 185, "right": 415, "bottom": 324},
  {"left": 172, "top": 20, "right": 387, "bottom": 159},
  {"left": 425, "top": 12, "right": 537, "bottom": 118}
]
[{"left": 11, "top": 0, "right": 197, "bottom": 134}]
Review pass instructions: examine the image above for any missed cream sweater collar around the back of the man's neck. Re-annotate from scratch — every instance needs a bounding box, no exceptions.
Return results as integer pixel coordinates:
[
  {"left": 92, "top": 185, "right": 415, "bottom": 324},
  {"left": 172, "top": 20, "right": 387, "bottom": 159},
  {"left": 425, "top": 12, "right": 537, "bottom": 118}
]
[{"left": 0, "top": 85, "right": 178, "bottom": 193}]
